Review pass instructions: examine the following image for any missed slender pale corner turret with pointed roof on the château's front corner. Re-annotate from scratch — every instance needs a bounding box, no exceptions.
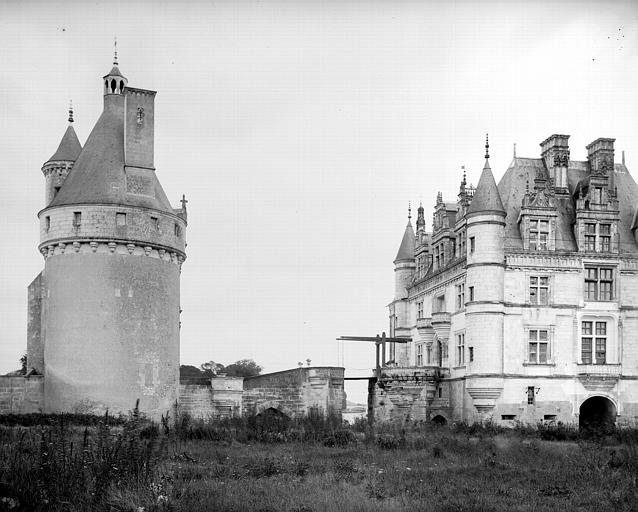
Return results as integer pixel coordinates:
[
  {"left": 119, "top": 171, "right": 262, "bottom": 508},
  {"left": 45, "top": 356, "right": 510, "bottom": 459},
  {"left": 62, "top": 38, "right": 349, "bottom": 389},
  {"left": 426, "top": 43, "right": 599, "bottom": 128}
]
[{"left": 464, "top": 136, "right": 506, "bottom": 414}]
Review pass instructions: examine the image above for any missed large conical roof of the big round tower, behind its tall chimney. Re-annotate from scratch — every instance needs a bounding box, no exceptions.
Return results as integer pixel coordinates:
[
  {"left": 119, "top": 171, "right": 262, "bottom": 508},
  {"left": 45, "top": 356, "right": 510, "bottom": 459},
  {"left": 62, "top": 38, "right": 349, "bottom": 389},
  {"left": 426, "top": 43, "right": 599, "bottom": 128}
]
[{"left": 49, "top": 93, "right": 174, "bottom": 214}]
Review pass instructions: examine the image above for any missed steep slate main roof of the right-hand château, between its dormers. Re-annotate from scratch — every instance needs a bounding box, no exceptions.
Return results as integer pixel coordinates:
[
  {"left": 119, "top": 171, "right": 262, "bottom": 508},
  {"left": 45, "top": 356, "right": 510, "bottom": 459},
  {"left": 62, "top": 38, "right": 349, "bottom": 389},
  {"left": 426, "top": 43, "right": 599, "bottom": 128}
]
[{"left": 500, "top": 157, "right": 638, "bottom": 253}]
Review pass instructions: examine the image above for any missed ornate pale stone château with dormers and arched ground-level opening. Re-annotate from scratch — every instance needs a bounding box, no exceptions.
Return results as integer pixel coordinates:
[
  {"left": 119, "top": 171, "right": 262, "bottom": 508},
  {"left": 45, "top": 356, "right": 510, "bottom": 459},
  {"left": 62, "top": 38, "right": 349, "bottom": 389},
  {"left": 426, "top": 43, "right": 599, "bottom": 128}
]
[{"left": 376, "top": 135, "right": 638, "bottom": 425}]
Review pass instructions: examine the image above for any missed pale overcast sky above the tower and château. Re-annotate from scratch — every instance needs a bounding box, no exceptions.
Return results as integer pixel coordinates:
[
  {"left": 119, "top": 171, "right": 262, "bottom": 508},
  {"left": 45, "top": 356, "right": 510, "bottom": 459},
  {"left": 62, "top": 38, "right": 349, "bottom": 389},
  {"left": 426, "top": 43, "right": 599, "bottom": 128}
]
[{"left": 0, "top": 0, "right": 638, "bottom": 401}]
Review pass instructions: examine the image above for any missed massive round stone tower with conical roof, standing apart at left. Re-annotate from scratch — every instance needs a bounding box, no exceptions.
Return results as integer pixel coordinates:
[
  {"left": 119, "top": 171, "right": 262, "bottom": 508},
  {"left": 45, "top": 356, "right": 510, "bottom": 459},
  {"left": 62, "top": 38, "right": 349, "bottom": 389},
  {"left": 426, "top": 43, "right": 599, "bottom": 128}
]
[{"left": 28, "top": 54, "right": 186, "bottom": 419}]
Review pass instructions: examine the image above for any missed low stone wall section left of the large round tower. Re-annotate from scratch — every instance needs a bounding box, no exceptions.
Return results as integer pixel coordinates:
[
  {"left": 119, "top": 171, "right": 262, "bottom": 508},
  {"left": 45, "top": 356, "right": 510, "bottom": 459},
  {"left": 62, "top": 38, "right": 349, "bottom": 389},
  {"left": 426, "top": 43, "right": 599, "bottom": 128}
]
[{"left": 0, "top": 375, "right": 44, "bottom": 414}]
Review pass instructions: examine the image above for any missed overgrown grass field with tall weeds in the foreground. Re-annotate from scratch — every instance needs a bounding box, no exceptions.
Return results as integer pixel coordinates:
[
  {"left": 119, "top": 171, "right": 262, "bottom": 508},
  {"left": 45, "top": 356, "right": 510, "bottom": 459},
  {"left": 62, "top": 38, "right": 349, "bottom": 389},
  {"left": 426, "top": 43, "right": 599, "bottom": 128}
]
[{"left": 0, "top": 417, "right": 638, "bottom": 512}]
